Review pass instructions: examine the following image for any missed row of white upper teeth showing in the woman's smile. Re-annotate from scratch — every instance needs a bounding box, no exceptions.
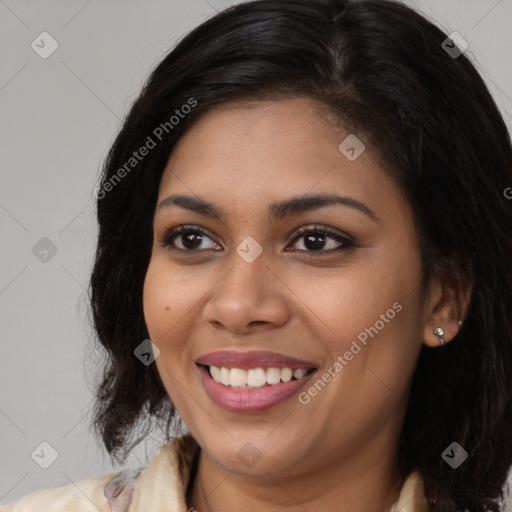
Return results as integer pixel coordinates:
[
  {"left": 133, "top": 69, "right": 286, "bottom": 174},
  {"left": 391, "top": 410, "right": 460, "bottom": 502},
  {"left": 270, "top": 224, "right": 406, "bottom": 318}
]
[{"left": 210, "top": 366, "right": 309, "bottom": 388}]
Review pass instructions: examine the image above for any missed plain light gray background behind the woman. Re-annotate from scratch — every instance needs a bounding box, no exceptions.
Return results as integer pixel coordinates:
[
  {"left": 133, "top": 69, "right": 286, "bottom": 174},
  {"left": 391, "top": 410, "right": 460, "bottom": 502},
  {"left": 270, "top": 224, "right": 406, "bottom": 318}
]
[{"left": 0, "top": 0, "right": 512, "bottom": 510}]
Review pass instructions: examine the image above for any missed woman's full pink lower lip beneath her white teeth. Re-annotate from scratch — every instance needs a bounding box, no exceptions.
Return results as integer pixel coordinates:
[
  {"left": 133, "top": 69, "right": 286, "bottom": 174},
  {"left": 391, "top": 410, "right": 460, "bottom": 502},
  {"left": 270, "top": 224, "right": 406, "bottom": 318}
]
[{"left": 198, "top": 365, "right": 316, "bottom": 412}]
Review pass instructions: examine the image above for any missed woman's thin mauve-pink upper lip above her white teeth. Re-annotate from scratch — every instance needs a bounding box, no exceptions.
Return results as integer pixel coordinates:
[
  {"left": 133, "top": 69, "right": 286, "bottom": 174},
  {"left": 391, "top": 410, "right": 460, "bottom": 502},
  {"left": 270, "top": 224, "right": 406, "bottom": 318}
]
[{"left": 196, "top": 350, "right": 315, "bottom": 370}]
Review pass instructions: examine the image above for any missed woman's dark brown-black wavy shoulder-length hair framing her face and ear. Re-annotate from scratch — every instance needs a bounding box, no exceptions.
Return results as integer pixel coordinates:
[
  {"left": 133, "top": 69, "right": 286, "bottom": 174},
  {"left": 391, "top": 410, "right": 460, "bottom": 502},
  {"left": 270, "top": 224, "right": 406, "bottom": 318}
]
[{"left": 90, "top": 0, "right": 512, "bottom": 512}]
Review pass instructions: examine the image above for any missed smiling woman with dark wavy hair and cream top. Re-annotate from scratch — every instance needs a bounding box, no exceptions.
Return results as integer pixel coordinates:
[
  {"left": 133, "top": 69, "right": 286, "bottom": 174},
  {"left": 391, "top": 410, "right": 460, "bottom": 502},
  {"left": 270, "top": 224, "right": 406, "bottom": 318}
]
[{"left": 2, "top": 0, "right": 512, "bottom": 512}]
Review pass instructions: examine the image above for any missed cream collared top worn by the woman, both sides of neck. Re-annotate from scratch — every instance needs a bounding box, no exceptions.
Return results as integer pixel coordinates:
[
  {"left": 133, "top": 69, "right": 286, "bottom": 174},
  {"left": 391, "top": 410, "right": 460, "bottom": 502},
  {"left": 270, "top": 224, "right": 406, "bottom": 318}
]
[{"left": 0, "top": 435, "right": 430, "bottom": 512}]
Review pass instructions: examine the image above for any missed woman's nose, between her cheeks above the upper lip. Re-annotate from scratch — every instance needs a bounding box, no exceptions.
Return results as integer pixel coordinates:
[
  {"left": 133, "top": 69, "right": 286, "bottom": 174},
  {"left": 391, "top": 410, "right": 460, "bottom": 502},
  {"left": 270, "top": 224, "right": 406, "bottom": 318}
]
[{"left": 203, "top": 252, "right": 290, "bottom": 334}]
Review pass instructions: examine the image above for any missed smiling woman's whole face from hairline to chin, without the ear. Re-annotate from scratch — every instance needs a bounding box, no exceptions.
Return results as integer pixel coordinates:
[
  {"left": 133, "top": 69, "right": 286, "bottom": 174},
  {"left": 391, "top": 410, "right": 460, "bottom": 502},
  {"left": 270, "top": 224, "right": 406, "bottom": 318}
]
[{"left": 144, "top": 98, "right": 426, "bottom": 475}]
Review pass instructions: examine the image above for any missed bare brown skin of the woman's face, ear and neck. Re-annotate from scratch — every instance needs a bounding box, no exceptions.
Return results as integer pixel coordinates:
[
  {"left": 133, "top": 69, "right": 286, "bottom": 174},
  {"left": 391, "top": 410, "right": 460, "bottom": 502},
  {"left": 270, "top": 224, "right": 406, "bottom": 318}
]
[{"left": 144, "top": 98, "right": 464, "bottom": 512}]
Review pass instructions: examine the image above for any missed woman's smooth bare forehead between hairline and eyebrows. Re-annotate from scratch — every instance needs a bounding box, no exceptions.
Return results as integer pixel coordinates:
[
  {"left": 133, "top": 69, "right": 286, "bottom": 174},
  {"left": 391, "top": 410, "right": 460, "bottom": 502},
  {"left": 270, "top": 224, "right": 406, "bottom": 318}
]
[{"left": 156, "top": 98, "right": 396, "bottom": 213}]
